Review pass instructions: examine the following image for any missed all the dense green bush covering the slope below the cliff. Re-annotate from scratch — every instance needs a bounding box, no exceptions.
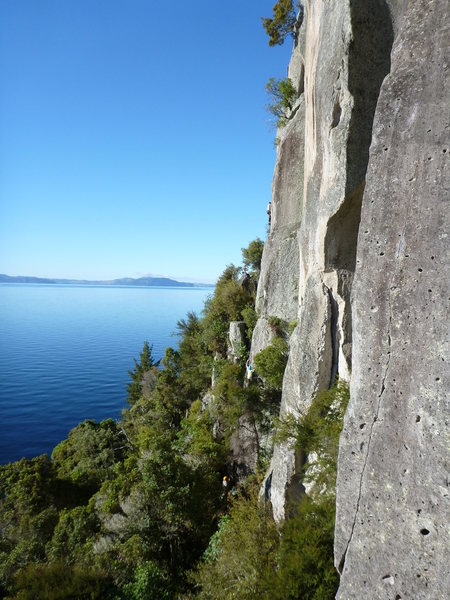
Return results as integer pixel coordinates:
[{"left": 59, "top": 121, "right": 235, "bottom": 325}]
[{"left": 0, "top": 240, "right": 345, "bottom": 600}]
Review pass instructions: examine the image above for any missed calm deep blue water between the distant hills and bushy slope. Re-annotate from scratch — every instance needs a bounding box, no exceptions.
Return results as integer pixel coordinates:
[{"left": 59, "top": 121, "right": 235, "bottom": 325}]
[{"left": 0, "top": 284, "right": 213, "bottom": 463}]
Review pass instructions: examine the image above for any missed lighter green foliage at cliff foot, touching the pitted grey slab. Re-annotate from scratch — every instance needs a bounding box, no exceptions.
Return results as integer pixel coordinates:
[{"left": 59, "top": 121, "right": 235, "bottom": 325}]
[{"left": 195, "top": 382, "right": 348, "bottom": 600}]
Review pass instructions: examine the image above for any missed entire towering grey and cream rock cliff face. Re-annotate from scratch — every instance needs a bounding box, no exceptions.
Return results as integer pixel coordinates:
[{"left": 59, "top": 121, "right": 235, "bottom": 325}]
[{"left": 251, "top": 0, "right": 449, "bottom": 600}]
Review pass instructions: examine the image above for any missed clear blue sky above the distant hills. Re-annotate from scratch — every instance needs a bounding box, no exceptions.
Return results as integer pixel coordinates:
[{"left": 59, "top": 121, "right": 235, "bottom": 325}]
[{"left": 0, "top": 0, "right": 291, "bottom": 282}]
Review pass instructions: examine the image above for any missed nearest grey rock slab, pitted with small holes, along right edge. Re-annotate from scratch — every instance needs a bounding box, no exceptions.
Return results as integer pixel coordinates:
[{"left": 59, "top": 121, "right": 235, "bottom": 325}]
[{"left": 335, "top": 0, "right": 450, "bottom": 600}]
